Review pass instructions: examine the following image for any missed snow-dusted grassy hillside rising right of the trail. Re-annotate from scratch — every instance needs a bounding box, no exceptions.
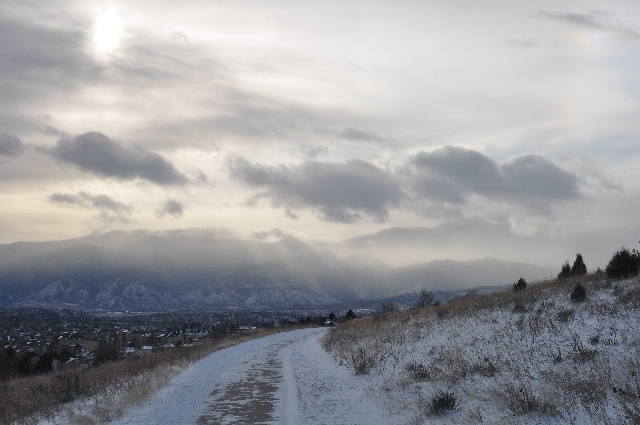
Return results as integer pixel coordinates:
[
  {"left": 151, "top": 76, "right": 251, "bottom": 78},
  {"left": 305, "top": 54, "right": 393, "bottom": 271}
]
[{"left": 322, "top": 274, "right": 640, "bottom": 424}]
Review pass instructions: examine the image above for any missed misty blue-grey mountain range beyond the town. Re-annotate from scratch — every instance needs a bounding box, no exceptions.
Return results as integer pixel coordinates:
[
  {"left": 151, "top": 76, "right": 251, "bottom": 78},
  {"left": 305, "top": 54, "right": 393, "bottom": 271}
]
[{"left": 0, "top": 229, "right": 553, "bottom": 311}]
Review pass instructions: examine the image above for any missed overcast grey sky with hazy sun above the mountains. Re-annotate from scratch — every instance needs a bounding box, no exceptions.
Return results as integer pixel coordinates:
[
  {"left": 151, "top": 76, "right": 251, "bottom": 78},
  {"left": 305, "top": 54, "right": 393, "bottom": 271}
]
[{"left": 0, "top": 0, "right": 640, "bottom": 268}]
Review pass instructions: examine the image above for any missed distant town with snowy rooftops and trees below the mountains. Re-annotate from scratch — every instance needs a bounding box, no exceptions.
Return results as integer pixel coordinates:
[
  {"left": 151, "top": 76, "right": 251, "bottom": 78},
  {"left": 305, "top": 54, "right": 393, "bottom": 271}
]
[{"left": 0, "top": 307, "right": 358, "bottom": 373}]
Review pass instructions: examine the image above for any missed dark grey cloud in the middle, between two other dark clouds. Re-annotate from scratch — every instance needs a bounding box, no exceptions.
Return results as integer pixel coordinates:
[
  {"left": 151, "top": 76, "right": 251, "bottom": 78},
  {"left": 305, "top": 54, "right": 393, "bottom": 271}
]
[{"left": 229, "top": 156, "right": 402, "bottom": 223}]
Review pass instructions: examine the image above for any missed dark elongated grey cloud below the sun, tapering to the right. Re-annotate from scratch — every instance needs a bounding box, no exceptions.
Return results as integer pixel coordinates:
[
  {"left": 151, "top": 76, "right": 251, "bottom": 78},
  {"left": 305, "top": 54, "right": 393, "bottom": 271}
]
[{"left": 49, "top": 132, "right": 187, "bottom": 186}]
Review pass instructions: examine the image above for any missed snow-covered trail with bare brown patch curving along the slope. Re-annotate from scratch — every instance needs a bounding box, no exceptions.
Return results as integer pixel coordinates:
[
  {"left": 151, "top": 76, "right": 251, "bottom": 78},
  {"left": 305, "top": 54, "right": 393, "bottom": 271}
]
[{"left": 114, "top": 329, "right": 386, "bottom": 425}]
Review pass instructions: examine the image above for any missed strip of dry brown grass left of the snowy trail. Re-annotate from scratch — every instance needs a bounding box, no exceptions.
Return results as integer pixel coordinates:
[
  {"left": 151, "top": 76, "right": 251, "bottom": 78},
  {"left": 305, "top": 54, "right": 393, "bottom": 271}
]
[{"left": 0, "top": 330, "right": 278, "bottom": 424}]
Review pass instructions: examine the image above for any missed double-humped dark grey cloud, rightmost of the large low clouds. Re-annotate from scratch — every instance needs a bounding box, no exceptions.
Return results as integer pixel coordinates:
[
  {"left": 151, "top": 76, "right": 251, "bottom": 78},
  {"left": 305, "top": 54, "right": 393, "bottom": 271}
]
[{"left": 405, "top": 146, "right": 580, "bottom": 205}]
